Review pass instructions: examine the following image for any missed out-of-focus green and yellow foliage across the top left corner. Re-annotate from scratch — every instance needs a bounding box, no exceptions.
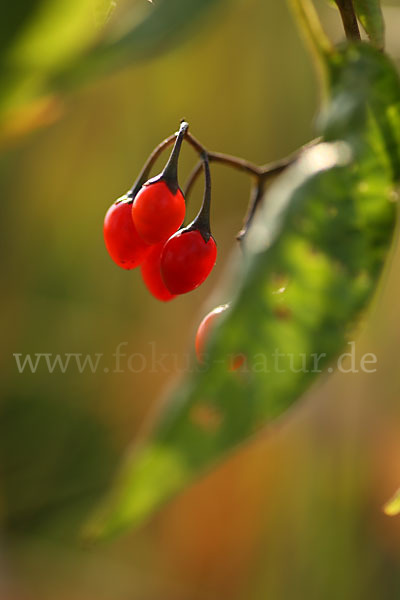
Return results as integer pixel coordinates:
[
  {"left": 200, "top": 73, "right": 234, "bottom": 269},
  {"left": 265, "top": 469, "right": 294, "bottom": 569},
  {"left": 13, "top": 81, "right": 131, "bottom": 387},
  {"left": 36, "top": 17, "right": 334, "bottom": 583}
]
[{"left": 0, "top": 0, "right": 222, "bottom": 136}]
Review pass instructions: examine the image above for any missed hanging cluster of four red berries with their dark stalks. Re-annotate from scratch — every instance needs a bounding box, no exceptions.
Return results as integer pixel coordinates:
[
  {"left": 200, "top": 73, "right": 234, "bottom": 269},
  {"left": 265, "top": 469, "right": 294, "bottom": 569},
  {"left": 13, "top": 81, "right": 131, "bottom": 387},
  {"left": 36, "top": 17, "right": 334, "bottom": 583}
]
[{"left": 103, "top": 122, "right": 217, "bottom": 302}]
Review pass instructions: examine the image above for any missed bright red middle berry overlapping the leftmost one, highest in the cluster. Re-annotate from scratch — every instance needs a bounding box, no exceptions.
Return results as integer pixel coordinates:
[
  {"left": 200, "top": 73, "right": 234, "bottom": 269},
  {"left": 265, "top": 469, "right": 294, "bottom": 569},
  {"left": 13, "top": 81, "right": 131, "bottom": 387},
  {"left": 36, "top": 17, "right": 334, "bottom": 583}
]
[{"left": 132, "top": 179, "right": 185, "bottom": 244}]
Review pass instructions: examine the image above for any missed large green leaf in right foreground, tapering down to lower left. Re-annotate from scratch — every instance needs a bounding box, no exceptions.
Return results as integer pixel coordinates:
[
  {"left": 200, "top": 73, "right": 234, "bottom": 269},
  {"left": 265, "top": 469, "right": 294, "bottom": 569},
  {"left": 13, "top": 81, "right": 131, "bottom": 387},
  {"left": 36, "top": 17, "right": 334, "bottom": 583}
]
[{"left": 87, "top": 44, "right": 400, "bottom": 537}]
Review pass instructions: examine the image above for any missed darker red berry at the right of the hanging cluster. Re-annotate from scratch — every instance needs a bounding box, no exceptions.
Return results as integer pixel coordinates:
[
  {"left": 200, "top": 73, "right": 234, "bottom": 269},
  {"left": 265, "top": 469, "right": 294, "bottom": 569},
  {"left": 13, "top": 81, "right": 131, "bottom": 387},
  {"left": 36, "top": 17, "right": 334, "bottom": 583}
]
[{"left": 161, "top": 229, "right": 217, "bottom": 294}]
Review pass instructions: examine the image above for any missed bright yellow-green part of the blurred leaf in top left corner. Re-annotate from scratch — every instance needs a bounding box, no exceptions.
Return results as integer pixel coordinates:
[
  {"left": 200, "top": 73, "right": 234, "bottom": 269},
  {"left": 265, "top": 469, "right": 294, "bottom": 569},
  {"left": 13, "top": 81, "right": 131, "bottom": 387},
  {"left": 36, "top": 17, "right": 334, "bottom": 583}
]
[{"left": 0, "top": 0, "right": 101, "bottom": 124}]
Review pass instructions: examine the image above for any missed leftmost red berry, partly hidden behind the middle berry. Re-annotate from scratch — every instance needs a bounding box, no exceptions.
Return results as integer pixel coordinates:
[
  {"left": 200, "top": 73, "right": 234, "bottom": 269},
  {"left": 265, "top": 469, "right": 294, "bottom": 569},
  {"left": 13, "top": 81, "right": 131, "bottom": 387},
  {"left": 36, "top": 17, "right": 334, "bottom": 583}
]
[{"left": 103, "top": 200, "right": 150, "bottom": 269}]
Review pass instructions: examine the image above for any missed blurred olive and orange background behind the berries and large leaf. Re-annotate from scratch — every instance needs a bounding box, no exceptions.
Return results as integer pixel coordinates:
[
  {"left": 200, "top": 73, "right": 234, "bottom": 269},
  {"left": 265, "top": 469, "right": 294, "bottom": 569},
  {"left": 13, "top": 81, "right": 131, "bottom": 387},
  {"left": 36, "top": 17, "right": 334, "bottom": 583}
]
[{"left": 0, "top": 0, "right": 400, "bottom": 600}]
